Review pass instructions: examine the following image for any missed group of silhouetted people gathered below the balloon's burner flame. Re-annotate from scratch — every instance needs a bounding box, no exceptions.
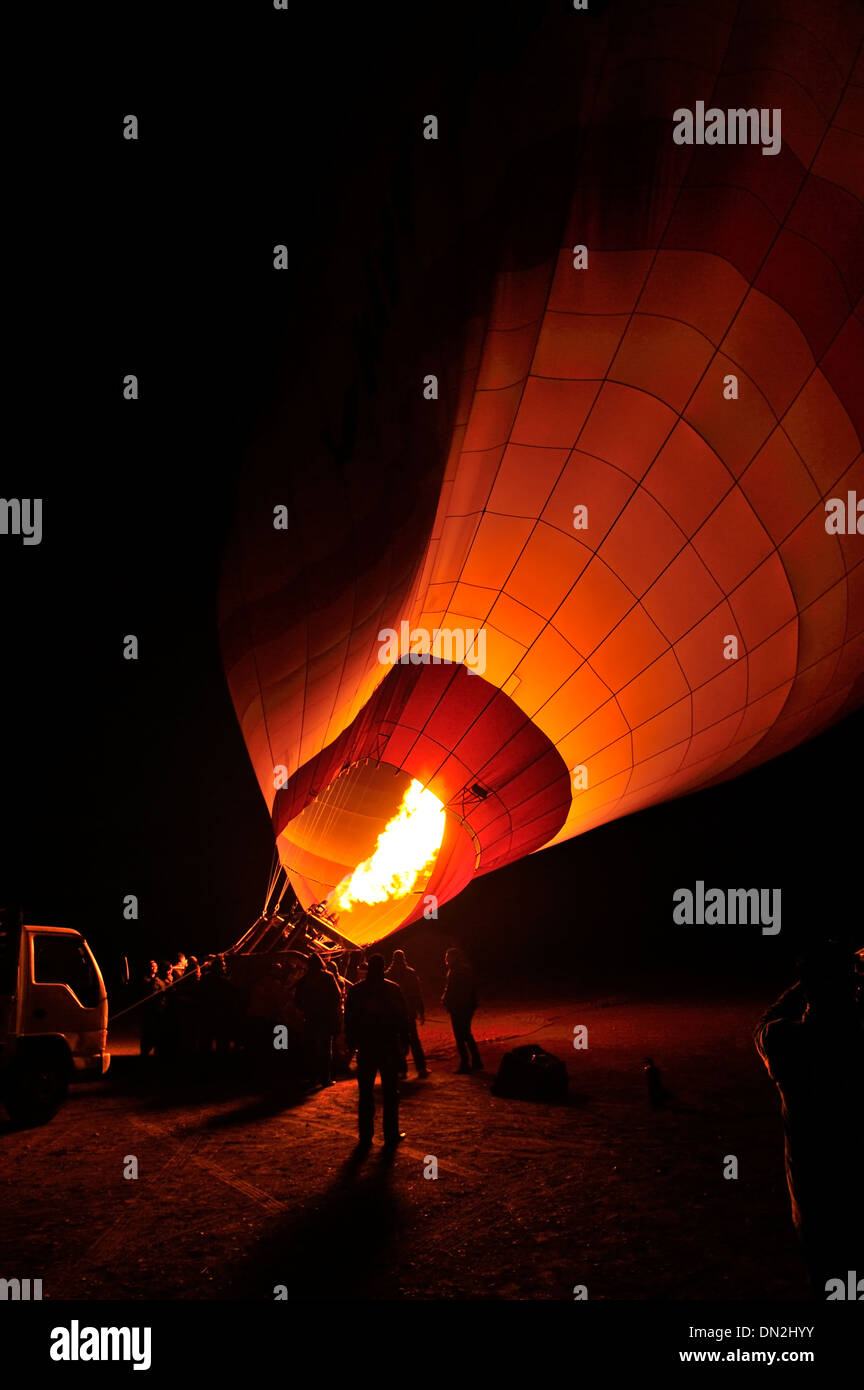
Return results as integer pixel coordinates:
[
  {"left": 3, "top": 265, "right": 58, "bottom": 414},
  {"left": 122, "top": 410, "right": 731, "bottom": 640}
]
[{"left": 140, "top": 947, "right": 483, "bottom": 1148}]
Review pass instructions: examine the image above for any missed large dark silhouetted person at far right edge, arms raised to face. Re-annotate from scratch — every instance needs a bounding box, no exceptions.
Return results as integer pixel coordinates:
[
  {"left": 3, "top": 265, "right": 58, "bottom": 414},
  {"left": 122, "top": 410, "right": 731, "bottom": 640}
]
[{"left": 756, "top": 942, "right": 864, "bottom": 1300}]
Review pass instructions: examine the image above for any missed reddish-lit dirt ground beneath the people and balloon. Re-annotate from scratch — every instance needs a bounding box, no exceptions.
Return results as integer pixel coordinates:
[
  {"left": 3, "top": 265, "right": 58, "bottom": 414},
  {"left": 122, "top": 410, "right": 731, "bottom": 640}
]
[{"left": 0, "top": 999, "right": 807, "bottom": 1301}]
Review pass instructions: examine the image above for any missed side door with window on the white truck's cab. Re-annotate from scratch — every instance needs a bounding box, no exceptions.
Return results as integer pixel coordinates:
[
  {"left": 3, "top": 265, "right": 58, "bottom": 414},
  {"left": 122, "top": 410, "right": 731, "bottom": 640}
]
[{"left": 19, "top": 927, "right": 106, "bottom": 1066}]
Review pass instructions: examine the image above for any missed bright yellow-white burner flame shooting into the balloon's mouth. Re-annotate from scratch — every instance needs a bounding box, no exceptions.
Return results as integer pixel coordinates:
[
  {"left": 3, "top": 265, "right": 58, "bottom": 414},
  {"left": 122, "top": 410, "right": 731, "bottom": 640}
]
[{"left": 333, "top": 778, "right": 446, "bottom": 912}]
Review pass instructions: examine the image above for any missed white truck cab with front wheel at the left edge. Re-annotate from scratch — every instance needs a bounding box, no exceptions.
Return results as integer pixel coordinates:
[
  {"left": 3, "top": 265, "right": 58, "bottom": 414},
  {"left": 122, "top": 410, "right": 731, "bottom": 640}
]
[{"left": 0, "top": 915, "right": 111, "bottom": 1126}]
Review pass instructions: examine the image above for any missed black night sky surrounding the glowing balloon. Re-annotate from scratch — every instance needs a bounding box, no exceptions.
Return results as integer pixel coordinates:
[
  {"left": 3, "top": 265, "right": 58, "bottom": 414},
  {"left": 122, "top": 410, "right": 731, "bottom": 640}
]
[{"left": 0, "top": 3, "right": 863, "bottom": 994}]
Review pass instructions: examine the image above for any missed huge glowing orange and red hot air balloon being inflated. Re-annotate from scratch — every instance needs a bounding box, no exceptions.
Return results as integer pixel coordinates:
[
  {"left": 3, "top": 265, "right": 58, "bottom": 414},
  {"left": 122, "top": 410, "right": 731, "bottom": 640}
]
[{"left": 221, "top": 3, "right": 864, "bottom": 945}]
